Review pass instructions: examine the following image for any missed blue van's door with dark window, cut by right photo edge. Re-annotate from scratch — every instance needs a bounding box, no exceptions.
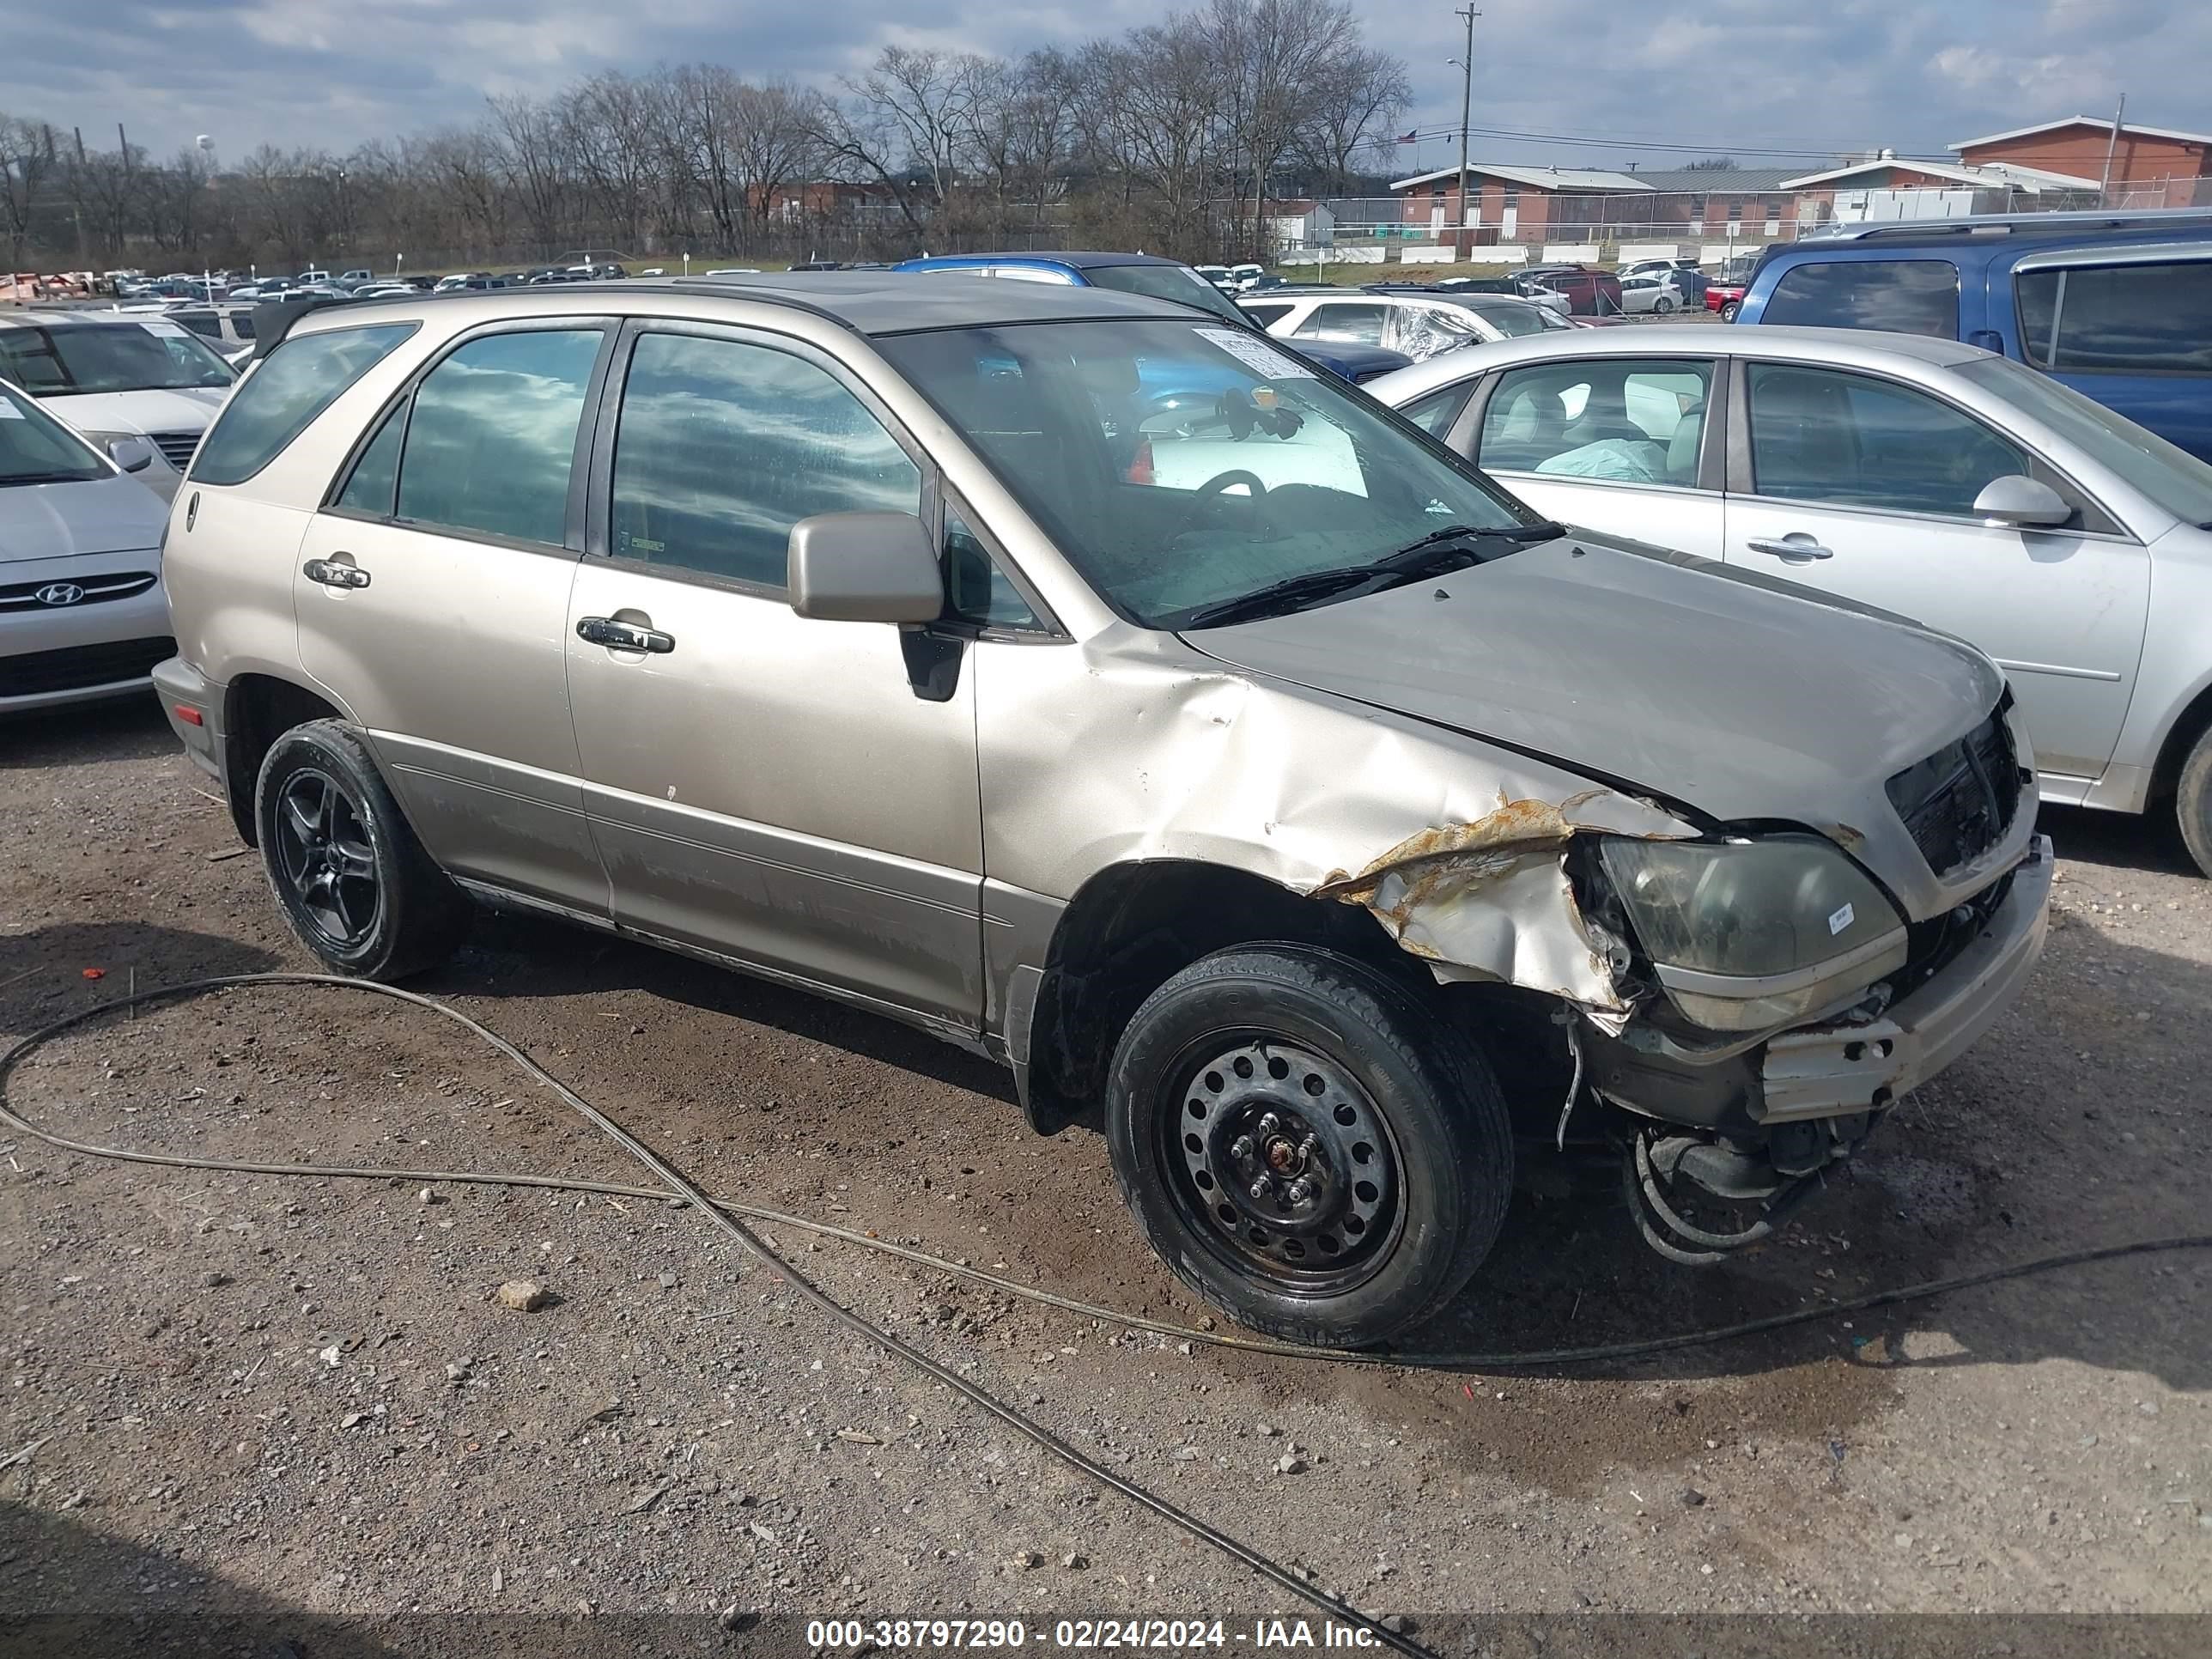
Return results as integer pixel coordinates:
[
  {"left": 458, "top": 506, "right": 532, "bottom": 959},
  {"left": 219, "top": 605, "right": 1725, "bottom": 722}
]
[{"left": 2013, "top": 243, "right": 2212, "bottom": 460}]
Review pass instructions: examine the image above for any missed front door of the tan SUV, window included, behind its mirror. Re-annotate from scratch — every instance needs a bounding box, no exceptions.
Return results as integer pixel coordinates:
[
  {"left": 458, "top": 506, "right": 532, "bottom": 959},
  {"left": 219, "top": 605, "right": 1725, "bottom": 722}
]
[{"left": 566, "top": 323, "right": 982, "bottom": 1030}]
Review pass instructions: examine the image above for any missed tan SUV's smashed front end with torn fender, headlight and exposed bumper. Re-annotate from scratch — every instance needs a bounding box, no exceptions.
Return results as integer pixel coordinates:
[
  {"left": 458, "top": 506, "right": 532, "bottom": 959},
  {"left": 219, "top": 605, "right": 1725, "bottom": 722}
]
[{"left": 1312, "top": 790, "right": 2051, "bottom": 1265}]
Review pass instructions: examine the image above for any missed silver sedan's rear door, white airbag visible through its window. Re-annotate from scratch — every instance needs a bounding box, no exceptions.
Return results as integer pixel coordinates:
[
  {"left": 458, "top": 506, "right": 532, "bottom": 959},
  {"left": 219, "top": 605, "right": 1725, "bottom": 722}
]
[{"left": 1451, "top": 354, "right": 1721, "bottom": 560}]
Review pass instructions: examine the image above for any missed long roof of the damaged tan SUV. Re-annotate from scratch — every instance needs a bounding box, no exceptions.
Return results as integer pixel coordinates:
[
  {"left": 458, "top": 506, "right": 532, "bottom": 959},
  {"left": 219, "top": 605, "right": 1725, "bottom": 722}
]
[{"left": 285, "top": 273, "right": 1194, "bottom": 356}]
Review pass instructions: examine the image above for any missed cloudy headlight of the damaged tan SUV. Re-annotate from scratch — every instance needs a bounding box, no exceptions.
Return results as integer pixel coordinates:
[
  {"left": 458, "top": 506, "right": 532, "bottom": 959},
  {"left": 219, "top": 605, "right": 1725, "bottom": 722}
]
[{"left": 1601, "top": 834, "right": 1907, "bottom": 1030}]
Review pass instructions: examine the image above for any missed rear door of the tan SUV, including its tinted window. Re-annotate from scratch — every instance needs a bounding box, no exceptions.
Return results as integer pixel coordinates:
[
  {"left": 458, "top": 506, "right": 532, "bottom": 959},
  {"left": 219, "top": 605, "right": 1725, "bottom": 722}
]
[{"left": 292, "top": 321, "right": 613, "bottom": 915}]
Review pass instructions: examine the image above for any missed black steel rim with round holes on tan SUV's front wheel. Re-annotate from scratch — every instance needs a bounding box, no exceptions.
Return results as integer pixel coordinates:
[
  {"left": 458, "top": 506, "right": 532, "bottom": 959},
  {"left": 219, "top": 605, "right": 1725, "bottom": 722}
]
[{"left": 1159, "top": 1033, "right": 1402, "bottom": 1297}]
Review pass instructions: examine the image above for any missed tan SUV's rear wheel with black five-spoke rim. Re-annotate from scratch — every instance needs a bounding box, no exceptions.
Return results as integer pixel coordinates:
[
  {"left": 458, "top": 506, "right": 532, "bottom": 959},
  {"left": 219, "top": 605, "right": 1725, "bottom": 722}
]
[{"left": 254, "top": 721, "right": 471, "bottom": 982}]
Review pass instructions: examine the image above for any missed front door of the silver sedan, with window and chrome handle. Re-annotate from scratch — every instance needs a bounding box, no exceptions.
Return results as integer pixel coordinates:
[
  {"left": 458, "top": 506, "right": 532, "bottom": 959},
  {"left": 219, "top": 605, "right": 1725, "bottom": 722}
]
[{"left": 1728, "top": 362, "right": 2150, "bottom": 799}]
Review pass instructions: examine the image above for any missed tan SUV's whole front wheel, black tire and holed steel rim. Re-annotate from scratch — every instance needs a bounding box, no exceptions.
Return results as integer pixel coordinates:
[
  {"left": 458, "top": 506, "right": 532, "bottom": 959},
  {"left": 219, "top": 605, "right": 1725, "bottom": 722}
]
[{"left": 1106, "top": 945, "right": 1513, "bottom": 1347}]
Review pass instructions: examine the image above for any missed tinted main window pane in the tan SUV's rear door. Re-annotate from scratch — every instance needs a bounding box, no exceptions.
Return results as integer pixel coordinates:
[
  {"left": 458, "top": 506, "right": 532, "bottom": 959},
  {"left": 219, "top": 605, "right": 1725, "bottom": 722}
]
[{"left": 398, "top": 327, "right": 602, "bottom": 546}]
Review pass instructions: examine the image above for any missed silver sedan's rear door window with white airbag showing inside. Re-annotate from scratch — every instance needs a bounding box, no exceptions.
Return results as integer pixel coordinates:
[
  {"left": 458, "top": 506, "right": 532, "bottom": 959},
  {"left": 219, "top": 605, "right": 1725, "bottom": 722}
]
[{"left": 1475, "top": 358, "right": 1712, "bottom": 489}]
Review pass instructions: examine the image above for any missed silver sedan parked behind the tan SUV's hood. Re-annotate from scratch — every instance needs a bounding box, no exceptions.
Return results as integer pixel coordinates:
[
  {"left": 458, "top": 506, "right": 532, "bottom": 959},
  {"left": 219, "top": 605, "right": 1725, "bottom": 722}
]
[{"left": 1367, "top": 327, "right": 2212, "bottom": 874}]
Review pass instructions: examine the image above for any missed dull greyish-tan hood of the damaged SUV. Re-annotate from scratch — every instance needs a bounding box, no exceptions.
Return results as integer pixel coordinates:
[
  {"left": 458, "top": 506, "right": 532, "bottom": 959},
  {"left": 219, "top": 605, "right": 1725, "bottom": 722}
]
[{"left": 1190, "top": 533, "right": 2004, "bottom": 830}]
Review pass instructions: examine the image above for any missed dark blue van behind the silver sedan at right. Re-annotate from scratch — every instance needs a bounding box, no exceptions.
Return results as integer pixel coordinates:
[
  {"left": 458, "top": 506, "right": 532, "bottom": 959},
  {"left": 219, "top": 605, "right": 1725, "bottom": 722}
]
[{"left": 1736, "top": 208, "right": 2212, "bottom": 460}]
